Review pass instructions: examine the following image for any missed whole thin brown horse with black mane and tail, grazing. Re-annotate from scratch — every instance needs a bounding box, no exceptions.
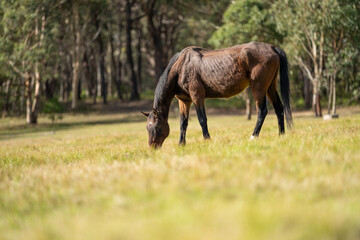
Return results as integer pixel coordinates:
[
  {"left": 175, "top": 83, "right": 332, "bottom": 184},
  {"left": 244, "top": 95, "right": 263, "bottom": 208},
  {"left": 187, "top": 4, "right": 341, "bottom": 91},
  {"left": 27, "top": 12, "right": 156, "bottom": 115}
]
[{"left": 143, "top": 42, "right": 292, "bottom": 148}]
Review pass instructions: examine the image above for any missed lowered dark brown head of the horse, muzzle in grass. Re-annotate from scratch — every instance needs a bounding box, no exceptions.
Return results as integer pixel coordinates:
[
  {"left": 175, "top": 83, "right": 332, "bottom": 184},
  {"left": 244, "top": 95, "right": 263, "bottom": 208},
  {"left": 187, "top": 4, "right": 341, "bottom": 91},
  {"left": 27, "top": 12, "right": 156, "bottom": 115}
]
[{"left": 142, "top": 109, "right": 170, "bottom": 148}]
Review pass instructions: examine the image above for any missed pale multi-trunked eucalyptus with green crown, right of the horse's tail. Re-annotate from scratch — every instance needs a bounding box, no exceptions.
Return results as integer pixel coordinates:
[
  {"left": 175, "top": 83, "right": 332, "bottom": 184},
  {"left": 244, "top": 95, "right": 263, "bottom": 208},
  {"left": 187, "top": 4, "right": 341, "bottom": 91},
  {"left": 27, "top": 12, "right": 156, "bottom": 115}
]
[{"left": 273, "top": 0, "right": 359, "bottom": 116}]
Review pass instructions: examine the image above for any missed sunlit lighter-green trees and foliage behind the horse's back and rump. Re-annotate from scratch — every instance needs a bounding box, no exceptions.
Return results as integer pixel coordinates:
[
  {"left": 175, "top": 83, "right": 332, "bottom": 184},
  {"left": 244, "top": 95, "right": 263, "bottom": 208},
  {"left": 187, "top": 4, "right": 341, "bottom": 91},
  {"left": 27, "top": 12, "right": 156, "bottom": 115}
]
[{"left": 209, "top": 0, "right": 360, "bottom": 115}]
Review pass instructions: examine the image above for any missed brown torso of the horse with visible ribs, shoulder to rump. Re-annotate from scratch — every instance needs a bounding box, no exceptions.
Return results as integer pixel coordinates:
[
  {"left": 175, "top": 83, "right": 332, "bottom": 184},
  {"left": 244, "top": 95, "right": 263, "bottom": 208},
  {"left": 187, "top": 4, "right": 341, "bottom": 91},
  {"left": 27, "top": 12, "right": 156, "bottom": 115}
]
[{"left": 179, "top": 42, "right": 279, "bottom": 98}]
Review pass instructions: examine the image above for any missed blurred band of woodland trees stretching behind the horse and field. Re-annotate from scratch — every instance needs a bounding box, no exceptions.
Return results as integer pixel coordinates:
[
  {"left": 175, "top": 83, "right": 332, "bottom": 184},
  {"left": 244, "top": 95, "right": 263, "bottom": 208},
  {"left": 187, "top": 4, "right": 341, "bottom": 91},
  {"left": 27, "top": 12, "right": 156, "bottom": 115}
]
[{"left": 0, "top": 0, "right": 360, "bottom": 123}]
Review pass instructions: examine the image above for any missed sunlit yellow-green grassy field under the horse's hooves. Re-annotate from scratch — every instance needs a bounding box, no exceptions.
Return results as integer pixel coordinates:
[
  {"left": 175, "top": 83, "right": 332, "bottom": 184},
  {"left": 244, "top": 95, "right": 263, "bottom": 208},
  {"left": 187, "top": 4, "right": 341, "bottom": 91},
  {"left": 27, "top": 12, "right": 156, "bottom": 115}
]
[{"left": 0, "top": 107, "right": 360, "bottom": 240}]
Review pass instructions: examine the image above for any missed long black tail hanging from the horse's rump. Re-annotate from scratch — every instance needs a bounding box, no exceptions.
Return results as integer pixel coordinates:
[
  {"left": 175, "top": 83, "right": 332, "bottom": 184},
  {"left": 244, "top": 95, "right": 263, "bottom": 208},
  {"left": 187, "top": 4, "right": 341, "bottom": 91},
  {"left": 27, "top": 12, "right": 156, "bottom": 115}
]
[{"left": 273, "top": 47, "right": 293, "bottom": 128}]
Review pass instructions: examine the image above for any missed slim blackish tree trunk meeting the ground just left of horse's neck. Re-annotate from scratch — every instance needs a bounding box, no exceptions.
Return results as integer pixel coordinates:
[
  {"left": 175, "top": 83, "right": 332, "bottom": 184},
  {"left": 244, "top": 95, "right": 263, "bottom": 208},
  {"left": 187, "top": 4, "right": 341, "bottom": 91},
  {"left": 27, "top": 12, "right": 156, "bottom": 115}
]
[{"left": 126, "top": 0, "right": 140, "bottom": 100}]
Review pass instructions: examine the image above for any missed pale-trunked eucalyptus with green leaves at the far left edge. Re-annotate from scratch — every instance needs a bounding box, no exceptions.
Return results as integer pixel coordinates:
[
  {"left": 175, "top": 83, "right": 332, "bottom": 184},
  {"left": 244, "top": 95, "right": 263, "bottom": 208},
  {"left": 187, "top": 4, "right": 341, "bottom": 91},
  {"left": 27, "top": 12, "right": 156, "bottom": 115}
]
[{"left": 0, "top": 0, "right": 51, "bottom": 124}]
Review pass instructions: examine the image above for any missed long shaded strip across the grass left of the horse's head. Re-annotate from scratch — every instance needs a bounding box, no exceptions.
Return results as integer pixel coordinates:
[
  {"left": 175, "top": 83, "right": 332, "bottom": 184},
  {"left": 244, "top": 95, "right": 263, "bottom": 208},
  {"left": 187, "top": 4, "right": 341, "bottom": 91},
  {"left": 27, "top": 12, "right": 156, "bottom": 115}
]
[{"left": 0, "top": 115, "right": 145, "bottom": 141}]
